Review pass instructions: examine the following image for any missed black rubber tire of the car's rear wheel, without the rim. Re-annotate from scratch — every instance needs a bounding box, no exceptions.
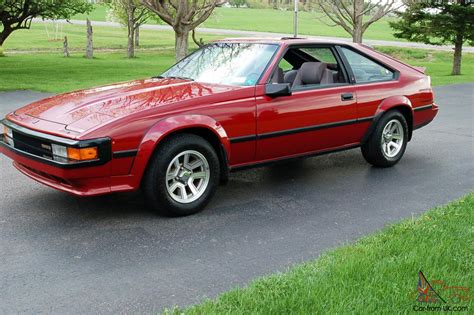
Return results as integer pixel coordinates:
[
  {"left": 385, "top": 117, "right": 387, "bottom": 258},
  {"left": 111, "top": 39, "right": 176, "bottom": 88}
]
[{"left": 361, "top": 110, "right": 408, "bottom": 167}]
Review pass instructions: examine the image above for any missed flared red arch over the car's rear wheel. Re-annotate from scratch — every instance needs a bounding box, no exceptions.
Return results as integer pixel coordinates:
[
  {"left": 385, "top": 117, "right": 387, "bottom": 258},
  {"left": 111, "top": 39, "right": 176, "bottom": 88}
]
[{"left": 361, "top": 96, "right": 413, "bottom": 144}]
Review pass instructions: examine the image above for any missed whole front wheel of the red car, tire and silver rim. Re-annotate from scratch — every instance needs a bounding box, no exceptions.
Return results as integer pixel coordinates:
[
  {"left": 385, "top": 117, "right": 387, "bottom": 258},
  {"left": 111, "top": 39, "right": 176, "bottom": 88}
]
[{"left": 143, "top": 134, "right": 220, "bottom": 216}]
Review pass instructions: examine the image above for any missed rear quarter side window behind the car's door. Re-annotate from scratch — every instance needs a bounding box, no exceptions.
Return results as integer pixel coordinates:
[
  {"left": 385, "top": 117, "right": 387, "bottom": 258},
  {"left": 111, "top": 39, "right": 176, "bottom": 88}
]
[{"left": 341, "top": 47, "right": 395, "bottom": 83}]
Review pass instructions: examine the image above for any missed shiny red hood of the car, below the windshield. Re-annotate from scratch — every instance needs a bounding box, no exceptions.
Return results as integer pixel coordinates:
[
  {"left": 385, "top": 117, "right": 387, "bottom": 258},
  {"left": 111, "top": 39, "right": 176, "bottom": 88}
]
[{"left": 11, "top": 79, "right": 244, "bottom": 133}]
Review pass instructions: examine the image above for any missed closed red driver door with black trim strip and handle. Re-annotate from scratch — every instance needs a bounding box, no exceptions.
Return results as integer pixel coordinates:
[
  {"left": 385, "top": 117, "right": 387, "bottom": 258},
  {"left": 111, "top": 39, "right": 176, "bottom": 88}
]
[{"left": 256, "top": 46, "right": 357, "bottom": 161}]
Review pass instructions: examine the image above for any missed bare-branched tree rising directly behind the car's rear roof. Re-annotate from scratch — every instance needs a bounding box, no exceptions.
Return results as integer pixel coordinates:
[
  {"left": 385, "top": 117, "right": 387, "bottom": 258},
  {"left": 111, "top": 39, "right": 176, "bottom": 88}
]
[{"left": 316, "top": 0, "right": 402, "bottom": 43}]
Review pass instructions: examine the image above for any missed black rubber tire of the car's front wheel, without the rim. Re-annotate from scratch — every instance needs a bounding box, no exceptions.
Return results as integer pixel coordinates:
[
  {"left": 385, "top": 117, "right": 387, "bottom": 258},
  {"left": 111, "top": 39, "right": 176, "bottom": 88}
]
[{"left": 143, "top": 134, "right": 220, "bottom": 216}]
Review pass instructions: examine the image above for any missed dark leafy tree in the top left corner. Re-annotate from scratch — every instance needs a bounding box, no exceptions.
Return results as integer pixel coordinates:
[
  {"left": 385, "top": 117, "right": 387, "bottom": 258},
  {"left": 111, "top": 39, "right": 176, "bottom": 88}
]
[{"left": 0, "top": 0, "right": 92, "bottom": 47}]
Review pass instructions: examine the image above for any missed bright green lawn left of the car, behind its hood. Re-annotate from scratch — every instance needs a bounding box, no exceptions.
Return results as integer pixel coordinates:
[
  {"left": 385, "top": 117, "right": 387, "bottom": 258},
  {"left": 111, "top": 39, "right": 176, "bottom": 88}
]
[{"left": 0, "top": 51, "right": 174, "bottom": 93}]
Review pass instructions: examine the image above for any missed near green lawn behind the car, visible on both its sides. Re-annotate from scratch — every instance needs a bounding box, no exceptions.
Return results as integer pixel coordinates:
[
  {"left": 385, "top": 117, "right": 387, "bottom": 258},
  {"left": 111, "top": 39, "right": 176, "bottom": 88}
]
[{"left": 0, "top": 45, "right": 474, "bottom": 93}]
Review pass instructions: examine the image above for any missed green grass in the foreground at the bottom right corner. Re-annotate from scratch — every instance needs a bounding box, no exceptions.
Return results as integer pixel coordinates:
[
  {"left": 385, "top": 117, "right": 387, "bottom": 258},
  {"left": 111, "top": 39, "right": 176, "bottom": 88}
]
[{"left": 168, "top": 193, "right": 474, "bottom": 314}]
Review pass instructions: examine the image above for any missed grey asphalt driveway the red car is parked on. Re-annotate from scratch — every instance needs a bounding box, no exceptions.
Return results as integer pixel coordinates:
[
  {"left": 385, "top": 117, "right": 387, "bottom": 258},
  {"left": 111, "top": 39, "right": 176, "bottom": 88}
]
[{"left": 0, "top": 84, "right": 474, "bottom": 314}]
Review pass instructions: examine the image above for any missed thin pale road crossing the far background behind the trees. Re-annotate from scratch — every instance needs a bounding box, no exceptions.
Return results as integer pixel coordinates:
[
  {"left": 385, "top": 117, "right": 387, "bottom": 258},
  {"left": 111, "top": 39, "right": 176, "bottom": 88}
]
[{"left": 35, "top": 19, "right": 474, "bottom": 52}]
